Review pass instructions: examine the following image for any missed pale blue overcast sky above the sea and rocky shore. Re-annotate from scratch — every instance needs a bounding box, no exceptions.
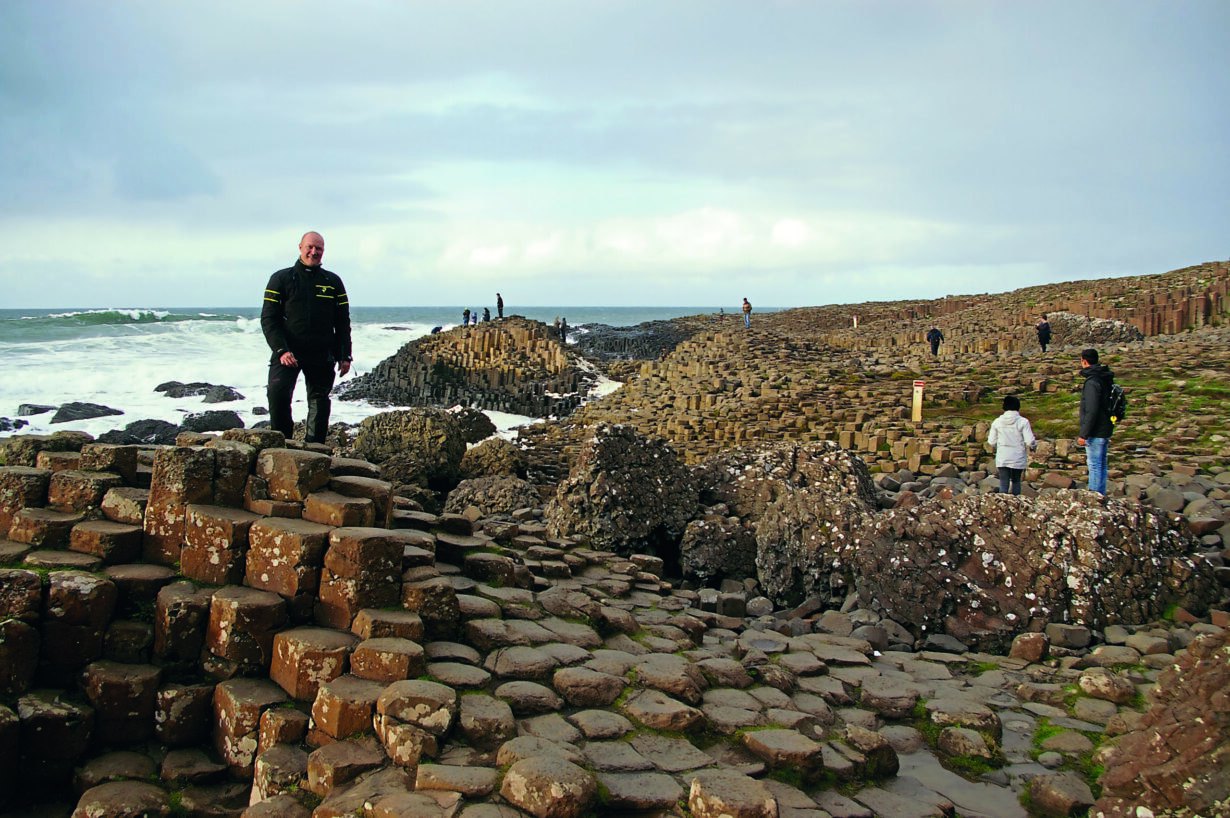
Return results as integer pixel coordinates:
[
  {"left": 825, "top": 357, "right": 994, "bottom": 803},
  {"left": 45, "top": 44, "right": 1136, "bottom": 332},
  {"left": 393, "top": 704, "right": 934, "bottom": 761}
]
[{"left": 0, "top": 0, "right": 1230, "bottom": 309}]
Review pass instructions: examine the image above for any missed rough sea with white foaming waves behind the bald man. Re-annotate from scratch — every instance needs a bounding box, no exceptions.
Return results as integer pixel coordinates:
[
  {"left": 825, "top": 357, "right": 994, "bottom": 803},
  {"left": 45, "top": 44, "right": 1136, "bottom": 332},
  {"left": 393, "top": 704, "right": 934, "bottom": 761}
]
[{"left": 0, "top": 304, "right": 717, "bottom": 437}]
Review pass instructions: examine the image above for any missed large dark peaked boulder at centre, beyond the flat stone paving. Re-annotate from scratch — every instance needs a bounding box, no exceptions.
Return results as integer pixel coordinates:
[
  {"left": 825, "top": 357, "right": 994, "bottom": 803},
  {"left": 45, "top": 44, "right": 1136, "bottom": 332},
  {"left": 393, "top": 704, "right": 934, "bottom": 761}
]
[{"left": 544, "top": 423, "right": 699, "bottom": 562}]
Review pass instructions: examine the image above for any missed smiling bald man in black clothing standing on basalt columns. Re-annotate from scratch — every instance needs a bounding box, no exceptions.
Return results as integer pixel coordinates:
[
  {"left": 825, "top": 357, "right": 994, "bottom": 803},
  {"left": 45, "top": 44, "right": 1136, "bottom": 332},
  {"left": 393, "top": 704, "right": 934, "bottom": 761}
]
[{"left": 261, "top": 232, "right": 351, "bottom": 443}]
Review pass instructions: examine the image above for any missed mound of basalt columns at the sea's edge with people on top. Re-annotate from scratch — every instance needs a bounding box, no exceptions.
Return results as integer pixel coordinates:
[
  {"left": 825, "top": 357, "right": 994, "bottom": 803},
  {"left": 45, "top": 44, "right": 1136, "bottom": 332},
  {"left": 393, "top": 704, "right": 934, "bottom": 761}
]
[{"left": 335, "top": 316, "right": 593, "bottom": 417}]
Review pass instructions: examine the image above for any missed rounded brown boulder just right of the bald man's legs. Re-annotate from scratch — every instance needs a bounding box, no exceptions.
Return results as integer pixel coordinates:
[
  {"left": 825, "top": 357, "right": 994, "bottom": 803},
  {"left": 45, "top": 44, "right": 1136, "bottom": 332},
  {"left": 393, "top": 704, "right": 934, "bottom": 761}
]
[{"left": 354, "top": 408, "right": 465, "bottom": 483}]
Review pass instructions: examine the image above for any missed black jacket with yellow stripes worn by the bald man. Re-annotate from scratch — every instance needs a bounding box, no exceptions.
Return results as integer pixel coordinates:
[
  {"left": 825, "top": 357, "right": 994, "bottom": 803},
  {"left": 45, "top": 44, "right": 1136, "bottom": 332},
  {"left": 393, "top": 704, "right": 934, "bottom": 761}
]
[{"left": 261, "top": 261, "right": 351, "bottom": 362}]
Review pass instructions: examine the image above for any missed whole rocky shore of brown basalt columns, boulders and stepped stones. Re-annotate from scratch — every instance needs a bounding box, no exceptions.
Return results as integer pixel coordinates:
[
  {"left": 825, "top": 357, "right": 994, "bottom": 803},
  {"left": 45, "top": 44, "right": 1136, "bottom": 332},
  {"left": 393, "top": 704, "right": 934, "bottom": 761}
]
[{"left": 0, "top": 262, "right": 1230, "bottom": 818}]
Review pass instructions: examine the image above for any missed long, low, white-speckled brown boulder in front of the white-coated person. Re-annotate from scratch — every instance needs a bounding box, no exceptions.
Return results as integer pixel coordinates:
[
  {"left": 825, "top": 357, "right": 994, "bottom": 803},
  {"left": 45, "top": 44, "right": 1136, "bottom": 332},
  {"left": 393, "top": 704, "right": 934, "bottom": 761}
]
[{"left": 836, "top": 492, "right": 1221, "bottom": 651}]
